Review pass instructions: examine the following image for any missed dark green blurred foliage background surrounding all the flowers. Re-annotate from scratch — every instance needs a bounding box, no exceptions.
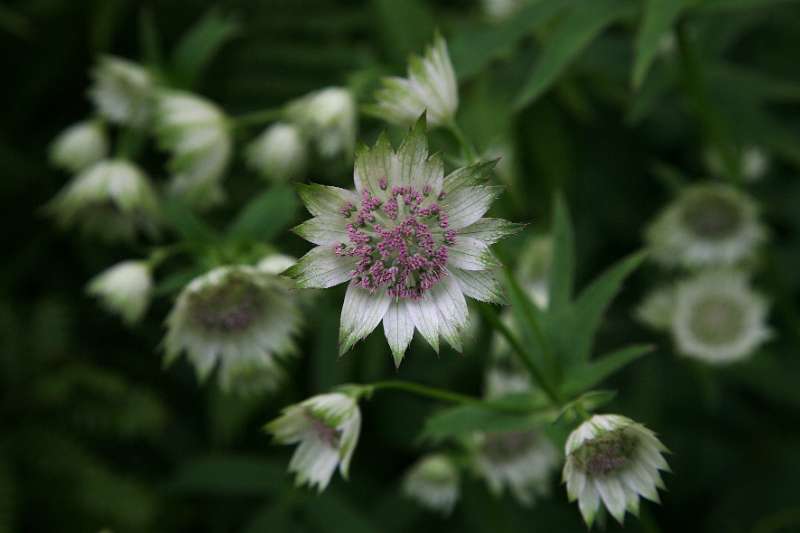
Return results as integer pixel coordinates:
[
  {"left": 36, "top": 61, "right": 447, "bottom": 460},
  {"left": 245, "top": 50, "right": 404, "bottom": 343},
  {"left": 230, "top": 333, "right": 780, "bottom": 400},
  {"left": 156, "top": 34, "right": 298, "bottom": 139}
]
[{"left": 0, "top": 0, "right": 800, "bottom": 533}]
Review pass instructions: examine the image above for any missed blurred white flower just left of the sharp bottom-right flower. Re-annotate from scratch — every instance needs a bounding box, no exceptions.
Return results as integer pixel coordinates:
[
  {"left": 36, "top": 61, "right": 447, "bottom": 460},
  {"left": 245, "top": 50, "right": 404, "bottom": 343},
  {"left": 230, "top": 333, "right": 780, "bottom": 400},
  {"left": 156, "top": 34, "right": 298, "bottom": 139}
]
[{"left": 474, "top": 431, "right": 558, "bottom": 506}]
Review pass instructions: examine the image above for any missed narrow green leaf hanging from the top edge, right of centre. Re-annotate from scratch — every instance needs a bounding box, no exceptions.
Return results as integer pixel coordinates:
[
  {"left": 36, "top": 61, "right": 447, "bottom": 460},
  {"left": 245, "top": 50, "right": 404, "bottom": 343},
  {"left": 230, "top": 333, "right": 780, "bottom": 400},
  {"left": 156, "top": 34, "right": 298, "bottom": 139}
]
[{"left": 632, "top": 0, "right": 686, "bottom": 88}]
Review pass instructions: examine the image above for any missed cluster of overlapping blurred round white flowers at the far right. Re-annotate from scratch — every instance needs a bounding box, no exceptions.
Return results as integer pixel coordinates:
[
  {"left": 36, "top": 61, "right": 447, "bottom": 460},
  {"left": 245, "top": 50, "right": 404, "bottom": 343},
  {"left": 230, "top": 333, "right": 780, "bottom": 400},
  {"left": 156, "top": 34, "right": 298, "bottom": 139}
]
[{"left": 637, "top": 184, "right": 770, "bottom": 364}]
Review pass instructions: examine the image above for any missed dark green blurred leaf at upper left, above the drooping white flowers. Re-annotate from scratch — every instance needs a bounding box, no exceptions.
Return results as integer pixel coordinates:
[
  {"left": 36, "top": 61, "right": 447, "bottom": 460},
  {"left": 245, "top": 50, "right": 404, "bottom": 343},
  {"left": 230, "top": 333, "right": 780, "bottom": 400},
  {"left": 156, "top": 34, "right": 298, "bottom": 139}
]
[{"left": 172, "top": 9, "right": 239, "bottom": 87}]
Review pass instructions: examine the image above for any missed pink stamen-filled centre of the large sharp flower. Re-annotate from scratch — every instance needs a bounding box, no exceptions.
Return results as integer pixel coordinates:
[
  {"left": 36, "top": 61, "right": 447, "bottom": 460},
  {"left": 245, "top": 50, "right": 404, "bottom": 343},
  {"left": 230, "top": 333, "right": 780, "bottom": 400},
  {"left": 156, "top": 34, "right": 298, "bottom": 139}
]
[{"left": 335, "top": 182, "right": 456, "bottom": 299}]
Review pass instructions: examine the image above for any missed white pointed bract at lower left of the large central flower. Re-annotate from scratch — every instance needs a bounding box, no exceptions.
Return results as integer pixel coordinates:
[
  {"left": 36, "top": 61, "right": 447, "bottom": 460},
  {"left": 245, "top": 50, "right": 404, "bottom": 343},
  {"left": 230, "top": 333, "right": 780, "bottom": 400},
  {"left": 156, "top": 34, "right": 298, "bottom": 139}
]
[{"left": 339, "top": 283, "right": 392, "bottom": 355}]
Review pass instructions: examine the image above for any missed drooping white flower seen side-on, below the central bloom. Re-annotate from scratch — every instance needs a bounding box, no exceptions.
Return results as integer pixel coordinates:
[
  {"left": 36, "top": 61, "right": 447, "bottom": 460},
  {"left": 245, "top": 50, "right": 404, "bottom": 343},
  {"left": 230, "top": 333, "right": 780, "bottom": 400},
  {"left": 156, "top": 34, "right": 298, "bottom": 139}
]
[{"left": 266, "top": 392, "right": 361, "bottom": 492}]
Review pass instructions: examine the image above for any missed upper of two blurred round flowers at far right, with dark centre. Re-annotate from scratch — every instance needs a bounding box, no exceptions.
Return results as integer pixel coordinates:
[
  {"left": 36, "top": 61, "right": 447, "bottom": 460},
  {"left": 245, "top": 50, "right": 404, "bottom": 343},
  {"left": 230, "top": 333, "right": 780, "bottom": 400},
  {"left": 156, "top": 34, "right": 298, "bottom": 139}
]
[{"left": 647, "top": 185, "right": 766, "bottom": 268}]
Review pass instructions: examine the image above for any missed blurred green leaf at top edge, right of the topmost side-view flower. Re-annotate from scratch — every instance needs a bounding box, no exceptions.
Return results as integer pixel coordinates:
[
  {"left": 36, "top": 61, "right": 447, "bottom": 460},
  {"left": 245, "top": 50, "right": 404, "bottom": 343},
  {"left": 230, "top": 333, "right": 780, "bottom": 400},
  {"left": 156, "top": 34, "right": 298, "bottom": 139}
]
[{"left": 449, "top": 0, "right": 573, "bottom": 81}]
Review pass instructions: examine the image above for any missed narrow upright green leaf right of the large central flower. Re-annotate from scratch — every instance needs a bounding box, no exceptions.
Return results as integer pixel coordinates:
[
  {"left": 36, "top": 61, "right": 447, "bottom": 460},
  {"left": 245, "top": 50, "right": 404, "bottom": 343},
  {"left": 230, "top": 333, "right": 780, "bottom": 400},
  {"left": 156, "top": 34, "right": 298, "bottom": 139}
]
[{"left": 548, "top": 194, "right": 575, "bottom": 312}]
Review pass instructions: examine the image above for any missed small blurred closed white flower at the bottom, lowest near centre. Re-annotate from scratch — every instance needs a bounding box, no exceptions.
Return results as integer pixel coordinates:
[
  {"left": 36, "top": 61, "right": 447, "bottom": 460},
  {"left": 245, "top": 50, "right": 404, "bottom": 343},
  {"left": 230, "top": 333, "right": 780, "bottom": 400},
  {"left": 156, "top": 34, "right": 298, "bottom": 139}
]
[{"left": 403, "top": 454, "right": 460, "bottom": 515}]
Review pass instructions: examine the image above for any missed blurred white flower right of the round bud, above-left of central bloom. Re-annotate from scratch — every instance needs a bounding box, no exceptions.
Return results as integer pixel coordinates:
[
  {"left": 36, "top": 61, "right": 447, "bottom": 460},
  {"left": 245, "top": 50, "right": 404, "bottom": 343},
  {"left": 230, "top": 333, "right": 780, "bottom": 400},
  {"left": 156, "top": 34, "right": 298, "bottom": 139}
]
[{"left": 286, "top": 87, "right": 358, "bottom": 158}]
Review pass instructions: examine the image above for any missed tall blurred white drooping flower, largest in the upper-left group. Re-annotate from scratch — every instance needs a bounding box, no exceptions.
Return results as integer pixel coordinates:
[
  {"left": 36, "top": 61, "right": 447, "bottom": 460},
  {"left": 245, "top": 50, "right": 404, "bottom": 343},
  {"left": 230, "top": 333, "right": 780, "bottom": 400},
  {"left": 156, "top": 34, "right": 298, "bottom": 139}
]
[{"left": 156, "top": 91, "right": 232, "bottom": 209}]
